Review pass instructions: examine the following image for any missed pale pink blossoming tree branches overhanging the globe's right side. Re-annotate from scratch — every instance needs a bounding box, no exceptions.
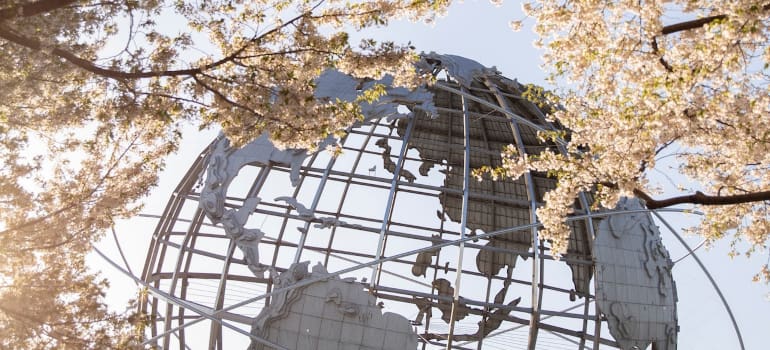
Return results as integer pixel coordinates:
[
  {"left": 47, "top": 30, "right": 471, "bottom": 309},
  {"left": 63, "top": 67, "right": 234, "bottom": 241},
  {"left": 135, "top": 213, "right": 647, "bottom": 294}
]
[{"left": 497, "top": 0, "right": 770, "bottom": 281}]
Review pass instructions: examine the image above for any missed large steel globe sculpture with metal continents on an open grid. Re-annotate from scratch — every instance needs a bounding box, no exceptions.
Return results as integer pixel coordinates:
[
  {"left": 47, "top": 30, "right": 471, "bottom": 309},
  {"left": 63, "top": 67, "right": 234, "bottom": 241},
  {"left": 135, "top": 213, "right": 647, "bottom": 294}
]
[{"left": 141, "top": 54, "right": 677, "bottom": 349}]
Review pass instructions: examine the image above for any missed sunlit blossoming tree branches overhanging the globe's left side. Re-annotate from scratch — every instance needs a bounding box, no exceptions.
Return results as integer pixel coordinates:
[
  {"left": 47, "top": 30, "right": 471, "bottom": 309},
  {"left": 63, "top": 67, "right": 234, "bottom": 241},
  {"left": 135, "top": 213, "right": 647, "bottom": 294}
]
[{"left": 0, "top": 0, "right": 448, "bottom": 349}]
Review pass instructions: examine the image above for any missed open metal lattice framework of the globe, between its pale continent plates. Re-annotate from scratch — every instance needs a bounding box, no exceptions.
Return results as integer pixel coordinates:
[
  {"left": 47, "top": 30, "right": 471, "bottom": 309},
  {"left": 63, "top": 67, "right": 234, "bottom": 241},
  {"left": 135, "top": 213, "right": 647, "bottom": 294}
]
[{"left": 134, "top": 58, "right": 744, "bottom": 349}]
